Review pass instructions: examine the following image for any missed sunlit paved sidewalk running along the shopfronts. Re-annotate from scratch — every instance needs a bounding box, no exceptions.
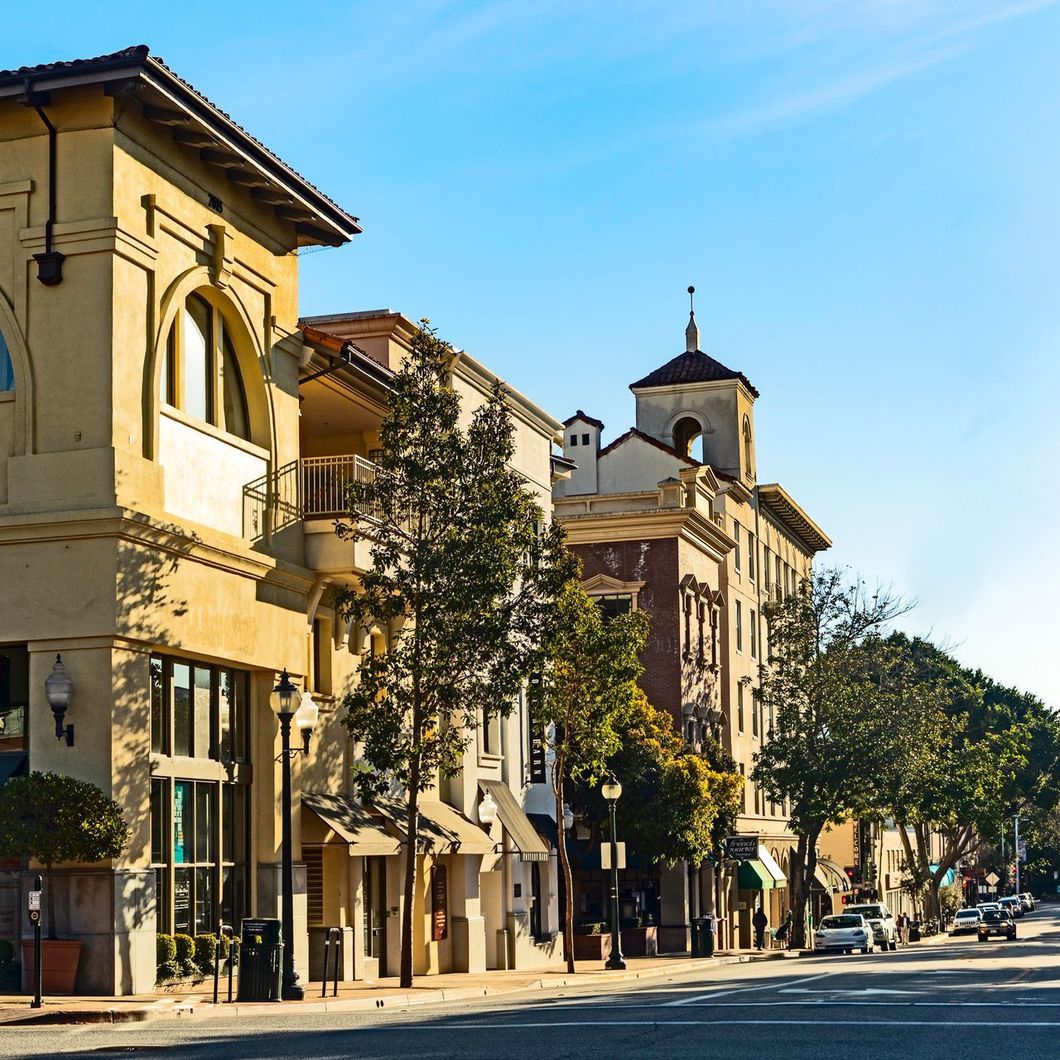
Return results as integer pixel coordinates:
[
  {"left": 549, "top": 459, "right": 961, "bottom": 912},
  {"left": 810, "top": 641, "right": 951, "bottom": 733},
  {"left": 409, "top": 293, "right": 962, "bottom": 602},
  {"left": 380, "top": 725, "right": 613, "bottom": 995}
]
[{"left": 0, "top": 950, "right": 796, "bottom": 1027}]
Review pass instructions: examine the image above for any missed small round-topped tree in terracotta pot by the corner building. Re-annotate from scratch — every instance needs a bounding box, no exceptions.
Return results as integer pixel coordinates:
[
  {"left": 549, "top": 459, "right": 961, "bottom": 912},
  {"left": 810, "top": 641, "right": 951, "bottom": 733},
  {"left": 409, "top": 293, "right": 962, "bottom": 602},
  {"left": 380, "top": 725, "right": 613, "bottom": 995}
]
[{"left": 0, "top": 773, "right": 129, "bottom": 994}]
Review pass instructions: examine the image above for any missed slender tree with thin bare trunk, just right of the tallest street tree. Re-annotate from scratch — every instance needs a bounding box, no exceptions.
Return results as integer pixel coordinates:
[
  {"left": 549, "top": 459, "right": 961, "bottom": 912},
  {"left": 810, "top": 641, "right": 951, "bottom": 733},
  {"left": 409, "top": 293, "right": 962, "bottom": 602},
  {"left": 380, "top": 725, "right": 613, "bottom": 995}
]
[{"left": 534, "top": 579, "right": 649, "bottom": 972}]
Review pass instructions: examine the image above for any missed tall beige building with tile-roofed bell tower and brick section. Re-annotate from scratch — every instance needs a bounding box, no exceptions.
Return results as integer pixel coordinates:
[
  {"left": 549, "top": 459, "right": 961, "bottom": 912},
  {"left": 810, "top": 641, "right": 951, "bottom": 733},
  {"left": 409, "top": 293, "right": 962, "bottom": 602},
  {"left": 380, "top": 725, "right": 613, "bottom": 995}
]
[{"left": 553, "top": 301, "right": 831, "bottom": 950}]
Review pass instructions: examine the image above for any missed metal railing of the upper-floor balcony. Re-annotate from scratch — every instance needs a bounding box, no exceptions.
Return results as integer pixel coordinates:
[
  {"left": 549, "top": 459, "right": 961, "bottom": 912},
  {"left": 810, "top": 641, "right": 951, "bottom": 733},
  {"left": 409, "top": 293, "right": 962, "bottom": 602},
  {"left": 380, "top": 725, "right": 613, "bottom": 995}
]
[{"left": 243, "top": 454, "right": 378, "bottom": 540}]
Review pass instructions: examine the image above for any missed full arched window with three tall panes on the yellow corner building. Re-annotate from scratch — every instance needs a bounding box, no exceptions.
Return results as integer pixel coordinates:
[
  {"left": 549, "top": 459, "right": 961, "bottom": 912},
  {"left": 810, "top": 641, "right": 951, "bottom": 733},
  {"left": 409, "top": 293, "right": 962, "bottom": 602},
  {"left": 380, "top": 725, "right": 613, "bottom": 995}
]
[{"left": 159, "top": 294, "right": 250, "bottom": 441}]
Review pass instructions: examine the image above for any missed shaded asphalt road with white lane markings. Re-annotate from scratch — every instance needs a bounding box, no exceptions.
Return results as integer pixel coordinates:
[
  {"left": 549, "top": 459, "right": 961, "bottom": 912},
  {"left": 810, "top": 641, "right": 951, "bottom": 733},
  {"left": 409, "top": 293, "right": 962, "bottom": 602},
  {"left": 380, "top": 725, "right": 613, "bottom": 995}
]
[{"left": 0, "top": 907, "right": 1060, "bottom": 1060}]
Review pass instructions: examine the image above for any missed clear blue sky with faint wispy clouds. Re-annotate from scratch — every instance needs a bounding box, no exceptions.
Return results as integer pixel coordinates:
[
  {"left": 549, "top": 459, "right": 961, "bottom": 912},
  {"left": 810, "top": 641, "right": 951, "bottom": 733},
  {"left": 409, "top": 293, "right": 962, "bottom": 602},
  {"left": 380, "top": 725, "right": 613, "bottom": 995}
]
[{"left": 8, "top": 6, "right": 1060, "bottom": 705}]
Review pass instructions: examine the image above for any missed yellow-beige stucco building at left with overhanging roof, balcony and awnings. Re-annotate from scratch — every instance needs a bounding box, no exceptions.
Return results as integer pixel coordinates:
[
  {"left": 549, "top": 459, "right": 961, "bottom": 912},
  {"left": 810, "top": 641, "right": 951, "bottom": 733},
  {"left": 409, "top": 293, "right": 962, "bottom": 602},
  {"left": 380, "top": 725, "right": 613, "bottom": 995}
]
[{"left": 0, "top": 48, "right": 561, "bottom": 993}]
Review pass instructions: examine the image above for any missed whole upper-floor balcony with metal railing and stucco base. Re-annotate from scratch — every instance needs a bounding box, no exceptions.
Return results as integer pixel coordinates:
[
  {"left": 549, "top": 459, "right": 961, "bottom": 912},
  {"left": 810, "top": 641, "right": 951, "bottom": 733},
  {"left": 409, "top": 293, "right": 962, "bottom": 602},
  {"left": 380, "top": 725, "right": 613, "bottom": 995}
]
[{"left": 243, "top": 454, "right": 378, "bottom": 570}]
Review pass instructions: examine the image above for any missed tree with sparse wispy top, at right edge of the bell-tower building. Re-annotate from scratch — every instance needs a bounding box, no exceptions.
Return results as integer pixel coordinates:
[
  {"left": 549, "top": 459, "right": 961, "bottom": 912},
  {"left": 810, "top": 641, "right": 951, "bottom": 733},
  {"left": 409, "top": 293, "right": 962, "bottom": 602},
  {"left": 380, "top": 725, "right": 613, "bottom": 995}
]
[{"left": 752, "top": 570, "right": 907, "bottom": 947}]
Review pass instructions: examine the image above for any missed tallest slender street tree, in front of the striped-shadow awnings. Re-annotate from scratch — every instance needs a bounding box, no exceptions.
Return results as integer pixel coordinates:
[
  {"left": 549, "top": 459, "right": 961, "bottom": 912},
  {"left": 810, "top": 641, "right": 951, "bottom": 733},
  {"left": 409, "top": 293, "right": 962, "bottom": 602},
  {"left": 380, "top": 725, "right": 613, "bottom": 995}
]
[{"left": 337, "top": 321, "right": 572, "bottom": 987}]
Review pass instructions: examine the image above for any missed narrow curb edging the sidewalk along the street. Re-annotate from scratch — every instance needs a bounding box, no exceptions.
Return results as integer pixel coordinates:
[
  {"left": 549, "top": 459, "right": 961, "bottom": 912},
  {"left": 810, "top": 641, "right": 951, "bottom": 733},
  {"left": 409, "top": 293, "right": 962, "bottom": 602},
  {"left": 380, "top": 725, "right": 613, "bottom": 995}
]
[{"left": 0, "top": 950, "right": 795, "bottom": 1027}]
